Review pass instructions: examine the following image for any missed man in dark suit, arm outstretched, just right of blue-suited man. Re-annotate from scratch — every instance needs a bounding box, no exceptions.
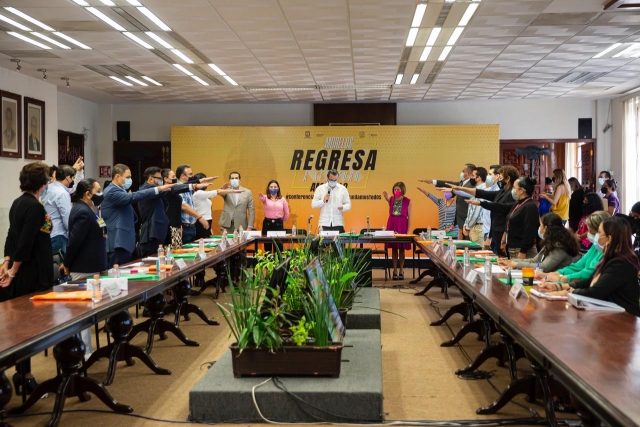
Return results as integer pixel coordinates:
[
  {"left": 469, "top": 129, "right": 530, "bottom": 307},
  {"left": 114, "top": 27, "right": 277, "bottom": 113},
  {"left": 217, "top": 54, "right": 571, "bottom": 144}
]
[{"left": 138, "top": 166, "right": 211, "bottom": 257}]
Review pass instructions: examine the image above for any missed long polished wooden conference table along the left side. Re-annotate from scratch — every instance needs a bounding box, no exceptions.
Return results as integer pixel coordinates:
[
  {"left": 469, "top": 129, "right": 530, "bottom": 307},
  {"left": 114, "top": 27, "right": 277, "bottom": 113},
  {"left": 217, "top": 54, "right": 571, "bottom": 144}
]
[{"left": 0, "top": 239, "right": 253, "bottom": 427}]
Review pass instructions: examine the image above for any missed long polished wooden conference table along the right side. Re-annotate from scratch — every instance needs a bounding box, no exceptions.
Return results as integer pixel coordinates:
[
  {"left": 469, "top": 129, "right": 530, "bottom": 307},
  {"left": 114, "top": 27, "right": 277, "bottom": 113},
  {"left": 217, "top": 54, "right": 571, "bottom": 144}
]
[{"left": 416, "top": 241, "right": 640, "bottom": 426}]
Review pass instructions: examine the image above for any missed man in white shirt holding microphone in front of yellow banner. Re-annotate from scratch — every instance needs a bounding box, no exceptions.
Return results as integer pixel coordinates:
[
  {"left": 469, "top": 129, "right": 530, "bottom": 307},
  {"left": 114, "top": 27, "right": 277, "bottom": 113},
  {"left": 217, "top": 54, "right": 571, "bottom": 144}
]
[{"left": 311, "top": 169, "right": 351, "bottom": 233}]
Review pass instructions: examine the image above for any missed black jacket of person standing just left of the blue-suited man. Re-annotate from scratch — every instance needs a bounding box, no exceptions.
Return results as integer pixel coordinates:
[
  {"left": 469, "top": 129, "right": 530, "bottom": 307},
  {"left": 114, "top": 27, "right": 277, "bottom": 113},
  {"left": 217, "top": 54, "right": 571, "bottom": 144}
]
[{"left": 64, "top": 201, "right": 109, "bottom": 273}]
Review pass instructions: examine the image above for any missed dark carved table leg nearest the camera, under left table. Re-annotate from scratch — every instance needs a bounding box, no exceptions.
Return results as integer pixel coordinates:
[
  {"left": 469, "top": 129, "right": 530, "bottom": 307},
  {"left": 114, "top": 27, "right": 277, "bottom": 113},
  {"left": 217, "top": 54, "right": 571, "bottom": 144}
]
[{"left": 9, "top": 335, "right": 133, "bottom": 427}]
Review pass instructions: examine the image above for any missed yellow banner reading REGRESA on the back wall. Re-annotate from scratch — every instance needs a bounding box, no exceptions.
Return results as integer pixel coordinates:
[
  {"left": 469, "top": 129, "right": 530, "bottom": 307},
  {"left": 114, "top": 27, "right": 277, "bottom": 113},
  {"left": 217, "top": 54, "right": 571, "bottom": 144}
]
[{"left": 171, "top": 125, "right": 500, "bottom": 233}]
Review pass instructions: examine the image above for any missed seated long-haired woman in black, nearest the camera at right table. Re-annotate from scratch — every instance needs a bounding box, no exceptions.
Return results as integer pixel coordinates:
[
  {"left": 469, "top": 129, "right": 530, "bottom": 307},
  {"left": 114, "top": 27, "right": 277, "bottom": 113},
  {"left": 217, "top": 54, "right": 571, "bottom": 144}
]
[{"left": 540, "top": 217, "right": 640, "bottom": 316}]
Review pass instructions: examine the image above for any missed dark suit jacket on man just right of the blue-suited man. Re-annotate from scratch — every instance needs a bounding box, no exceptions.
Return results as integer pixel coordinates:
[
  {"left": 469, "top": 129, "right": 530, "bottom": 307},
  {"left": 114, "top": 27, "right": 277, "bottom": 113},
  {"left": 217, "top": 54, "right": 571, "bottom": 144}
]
[{"left": 138, "top": 182, "right": 190, "bottom": 243}]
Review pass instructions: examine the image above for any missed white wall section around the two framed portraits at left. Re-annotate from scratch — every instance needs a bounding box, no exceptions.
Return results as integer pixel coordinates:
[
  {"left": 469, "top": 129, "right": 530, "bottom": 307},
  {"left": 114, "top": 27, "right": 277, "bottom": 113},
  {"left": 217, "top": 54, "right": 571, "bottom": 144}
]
[{"left": 0, "top": 68, "right": 58, "bottom": 245}]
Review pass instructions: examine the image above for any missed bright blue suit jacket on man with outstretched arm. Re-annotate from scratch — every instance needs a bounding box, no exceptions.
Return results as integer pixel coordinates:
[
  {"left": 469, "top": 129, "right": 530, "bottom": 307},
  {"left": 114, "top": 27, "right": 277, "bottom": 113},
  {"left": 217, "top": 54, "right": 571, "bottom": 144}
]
[{"left": 100, "top": 184, "right": 162, "bottom": 252}]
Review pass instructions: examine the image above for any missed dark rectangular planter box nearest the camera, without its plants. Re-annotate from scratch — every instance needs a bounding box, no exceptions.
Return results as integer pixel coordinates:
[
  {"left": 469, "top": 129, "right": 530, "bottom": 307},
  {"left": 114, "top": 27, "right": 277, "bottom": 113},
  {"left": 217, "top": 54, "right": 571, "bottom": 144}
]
[{"left": 229, "top": 343, "right": 343, "bottom": 378}]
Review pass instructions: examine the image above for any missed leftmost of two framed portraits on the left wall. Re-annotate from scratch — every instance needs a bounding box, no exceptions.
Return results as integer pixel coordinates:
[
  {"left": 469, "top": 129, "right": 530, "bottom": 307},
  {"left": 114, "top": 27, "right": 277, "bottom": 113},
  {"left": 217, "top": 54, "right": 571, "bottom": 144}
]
[{"left": 0, "top": 91, "right": 22, "bottom": 159}]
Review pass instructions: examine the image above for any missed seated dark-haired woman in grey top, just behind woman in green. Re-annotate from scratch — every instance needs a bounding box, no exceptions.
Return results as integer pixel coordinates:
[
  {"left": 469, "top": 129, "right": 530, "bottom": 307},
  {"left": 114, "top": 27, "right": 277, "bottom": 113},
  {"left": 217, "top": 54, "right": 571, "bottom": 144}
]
[{"left": 498, "top": 212, "right": 580, "bottom": 273}]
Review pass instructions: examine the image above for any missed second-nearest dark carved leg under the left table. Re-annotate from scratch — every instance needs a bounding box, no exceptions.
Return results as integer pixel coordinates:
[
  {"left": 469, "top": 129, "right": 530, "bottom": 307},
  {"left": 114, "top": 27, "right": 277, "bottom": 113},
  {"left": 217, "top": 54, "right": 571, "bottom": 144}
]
[{"left": 85, "top": 310, "right": 171, "bottom": 385}]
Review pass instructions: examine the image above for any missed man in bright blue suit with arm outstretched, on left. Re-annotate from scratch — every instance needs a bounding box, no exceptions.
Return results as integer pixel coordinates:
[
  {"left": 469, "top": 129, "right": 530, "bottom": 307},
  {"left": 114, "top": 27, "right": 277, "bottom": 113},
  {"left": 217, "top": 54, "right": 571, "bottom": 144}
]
[{"left": 100, "top": 164, "right": 173, "bottom": 266}]
